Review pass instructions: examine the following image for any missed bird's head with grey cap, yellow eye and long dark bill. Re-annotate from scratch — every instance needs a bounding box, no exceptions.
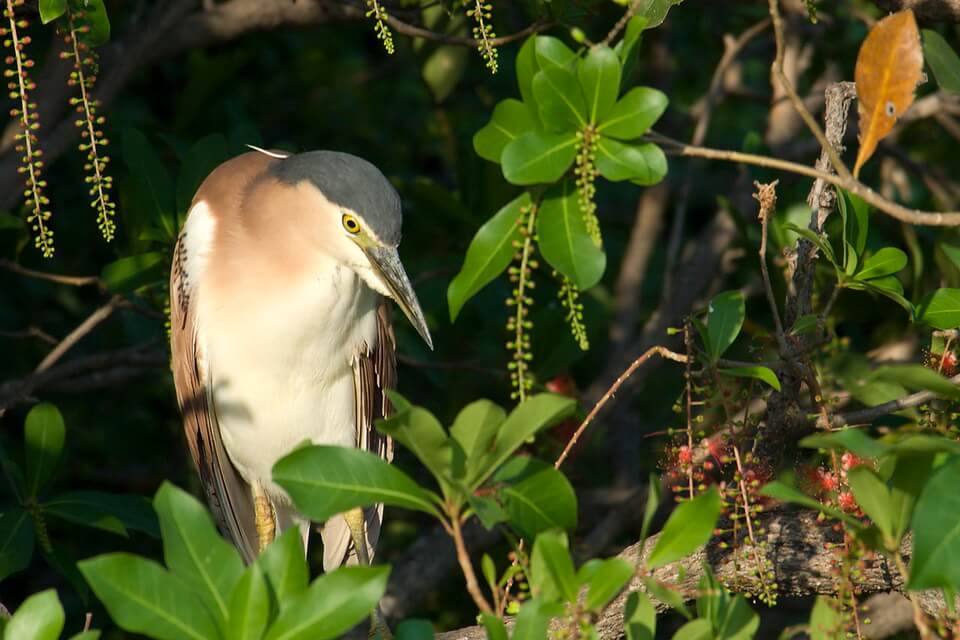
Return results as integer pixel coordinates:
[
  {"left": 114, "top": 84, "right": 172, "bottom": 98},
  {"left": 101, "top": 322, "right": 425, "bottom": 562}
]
[{"left": 271, "top": 151, "right": 433, "bottom": 349}]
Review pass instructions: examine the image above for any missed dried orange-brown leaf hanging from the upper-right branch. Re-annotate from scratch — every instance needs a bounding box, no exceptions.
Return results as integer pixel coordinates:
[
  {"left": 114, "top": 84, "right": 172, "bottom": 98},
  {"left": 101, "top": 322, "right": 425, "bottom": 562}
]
[{"left": 853, "top": 9, "right": 923, "bottom": 176}]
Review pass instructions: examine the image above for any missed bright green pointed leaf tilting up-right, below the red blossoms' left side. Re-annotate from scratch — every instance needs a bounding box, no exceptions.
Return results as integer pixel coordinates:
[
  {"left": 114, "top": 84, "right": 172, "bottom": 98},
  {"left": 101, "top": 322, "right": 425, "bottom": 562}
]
[{"left": 647, "top": 487, "right": 720, "bottom": 569}]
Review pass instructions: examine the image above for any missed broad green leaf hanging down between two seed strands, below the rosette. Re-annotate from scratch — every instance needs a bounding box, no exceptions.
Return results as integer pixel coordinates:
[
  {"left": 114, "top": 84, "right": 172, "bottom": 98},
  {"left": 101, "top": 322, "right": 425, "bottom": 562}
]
[{"left": 537, "top": 180, "right": 607, "bottom": 290}]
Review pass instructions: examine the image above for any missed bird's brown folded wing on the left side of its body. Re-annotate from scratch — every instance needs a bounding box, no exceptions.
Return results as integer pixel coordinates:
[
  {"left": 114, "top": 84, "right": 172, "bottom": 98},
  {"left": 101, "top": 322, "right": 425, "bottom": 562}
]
[{"left": 170, "top": 234, "right": 259, "bottom": 562}]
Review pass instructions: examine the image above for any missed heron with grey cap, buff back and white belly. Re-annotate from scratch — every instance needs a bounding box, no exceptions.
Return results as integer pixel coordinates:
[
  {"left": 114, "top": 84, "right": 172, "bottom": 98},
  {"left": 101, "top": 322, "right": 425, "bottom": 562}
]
[{"left": 170, "top": 147, "right": 433, "bottom": 571}]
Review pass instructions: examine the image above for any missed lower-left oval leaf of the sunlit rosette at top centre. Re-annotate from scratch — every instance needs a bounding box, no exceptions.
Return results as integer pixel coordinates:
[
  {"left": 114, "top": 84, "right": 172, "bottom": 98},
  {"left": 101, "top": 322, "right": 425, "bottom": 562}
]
[{"left": 500, "top": 131, "right": 577, "bottom": 185}]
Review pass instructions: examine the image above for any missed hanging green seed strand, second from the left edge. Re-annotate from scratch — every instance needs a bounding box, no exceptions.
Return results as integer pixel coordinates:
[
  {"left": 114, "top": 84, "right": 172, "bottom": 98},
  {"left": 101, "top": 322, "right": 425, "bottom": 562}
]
[{"left": 60, "top": 11, "right": 117, "bottom": 242}]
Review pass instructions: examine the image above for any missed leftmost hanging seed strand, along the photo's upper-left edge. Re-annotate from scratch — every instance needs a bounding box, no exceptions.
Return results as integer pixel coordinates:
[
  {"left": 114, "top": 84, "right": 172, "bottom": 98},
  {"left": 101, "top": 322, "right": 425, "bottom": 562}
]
[{"left": 0, "top": 0, "right": 53, "bottom": 258}]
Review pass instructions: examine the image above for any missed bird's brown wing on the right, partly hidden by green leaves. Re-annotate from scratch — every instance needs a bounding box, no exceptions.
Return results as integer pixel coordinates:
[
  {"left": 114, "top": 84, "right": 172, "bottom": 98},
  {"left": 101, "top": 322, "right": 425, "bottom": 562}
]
[{"left": 321, "top": 300, "right": 397, "bottom": 571}]
